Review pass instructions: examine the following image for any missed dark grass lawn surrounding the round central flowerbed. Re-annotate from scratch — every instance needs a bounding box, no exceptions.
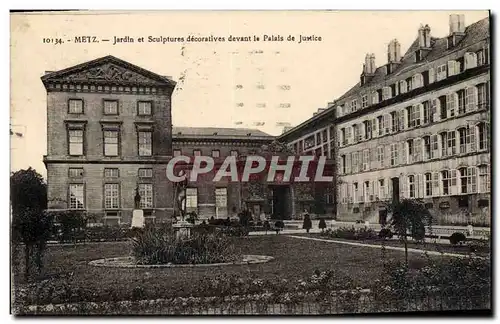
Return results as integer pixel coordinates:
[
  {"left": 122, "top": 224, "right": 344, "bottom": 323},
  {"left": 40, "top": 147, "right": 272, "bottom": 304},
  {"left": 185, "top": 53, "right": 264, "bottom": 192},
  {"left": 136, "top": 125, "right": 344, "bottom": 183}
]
[{"left": 14, "top": 235, "right": 446, "bottom": 303}]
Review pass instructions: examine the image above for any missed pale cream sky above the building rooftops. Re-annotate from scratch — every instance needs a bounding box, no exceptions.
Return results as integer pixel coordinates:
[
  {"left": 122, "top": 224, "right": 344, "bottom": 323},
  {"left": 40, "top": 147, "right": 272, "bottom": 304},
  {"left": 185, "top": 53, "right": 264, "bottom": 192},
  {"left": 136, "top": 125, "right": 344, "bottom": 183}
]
[{"left": 10, "top": 11, "right": 488, "bottom": 176}]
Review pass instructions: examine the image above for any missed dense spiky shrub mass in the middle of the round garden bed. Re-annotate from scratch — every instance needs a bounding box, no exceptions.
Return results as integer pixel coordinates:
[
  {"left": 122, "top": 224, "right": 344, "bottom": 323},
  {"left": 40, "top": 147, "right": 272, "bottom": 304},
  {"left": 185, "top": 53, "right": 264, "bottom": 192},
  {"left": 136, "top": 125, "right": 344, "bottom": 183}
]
[{"left": 132, "top": 229, "right": 239, "bottom": 264}]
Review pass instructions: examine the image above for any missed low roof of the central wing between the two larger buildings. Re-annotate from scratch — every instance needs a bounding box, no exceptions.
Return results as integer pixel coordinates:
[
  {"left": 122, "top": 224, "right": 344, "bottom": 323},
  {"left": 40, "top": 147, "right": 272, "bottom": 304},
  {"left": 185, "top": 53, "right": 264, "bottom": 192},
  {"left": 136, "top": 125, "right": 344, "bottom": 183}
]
[{"left": 172, "top": 126, "right": 274, "bottom": 139}]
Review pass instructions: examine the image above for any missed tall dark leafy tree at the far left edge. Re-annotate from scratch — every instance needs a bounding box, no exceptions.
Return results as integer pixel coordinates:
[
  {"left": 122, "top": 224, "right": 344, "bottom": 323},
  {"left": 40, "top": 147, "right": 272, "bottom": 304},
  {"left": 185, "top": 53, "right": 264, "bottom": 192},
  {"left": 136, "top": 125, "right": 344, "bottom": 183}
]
[{"left": 10, "top": 167, "right": 53, "bottom": 279}]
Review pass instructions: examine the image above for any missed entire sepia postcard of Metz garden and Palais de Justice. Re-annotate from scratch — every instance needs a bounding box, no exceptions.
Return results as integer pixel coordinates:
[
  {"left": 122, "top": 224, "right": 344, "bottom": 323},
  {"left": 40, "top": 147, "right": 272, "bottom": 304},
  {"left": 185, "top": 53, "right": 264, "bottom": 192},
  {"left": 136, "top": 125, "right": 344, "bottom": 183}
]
[{"left": 10, "top": 10, "right": 492, "bottom": 316}]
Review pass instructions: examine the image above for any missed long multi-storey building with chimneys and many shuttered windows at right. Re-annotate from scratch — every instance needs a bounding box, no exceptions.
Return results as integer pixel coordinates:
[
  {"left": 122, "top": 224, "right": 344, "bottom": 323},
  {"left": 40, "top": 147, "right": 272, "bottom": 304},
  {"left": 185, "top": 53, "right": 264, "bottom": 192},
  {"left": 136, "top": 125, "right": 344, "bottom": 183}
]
[{"left": 279, "top": 15, "right": 491, "bottom": 225}]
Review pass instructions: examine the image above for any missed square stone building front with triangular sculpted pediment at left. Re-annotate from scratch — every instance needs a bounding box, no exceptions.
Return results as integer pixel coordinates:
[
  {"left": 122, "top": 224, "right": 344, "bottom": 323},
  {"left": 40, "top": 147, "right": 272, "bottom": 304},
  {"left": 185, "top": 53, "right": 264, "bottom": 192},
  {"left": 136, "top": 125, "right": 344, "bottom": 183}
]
[{"left": 42, "top": 56, "right": 175, "bottom": 225}]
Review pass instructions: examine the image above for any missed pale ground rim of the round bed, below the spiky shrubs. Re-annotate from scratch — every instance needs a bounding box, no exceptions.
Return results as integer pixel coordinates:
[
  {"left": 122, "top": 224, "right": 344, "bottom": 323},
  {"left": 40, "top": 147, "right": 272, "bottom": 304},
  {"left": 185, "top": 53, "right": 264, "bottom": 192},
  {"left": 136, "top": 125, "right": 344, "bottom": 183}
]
[{"left": 89, "top": 255, "right": 274, "bottom": 268}]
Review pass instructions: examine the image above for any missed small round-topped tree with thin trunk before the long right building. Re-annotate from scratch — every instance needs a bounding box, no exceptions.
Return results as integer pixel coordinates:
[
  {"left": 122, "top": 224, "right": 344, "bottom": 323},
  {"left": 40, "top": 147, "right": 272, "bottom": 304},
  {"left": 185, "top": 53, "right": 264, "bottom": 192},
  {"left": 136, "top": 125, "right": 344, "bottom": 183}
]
[{"left": 389, "top": 199, "right": 432, "bottom": 267}]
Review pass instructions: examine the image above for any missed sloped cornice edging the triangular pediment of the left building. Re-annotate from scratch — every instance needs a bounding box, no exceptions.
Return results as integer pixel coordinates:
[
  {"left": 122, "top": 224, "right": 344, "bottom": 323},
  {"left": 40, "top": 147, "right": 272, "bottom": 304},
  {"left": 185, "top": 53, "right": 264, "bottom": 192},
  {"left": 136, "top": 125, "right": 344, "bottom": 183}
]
[{"left": 41, "top": 55, "right": 176, "bottom": 88}]
